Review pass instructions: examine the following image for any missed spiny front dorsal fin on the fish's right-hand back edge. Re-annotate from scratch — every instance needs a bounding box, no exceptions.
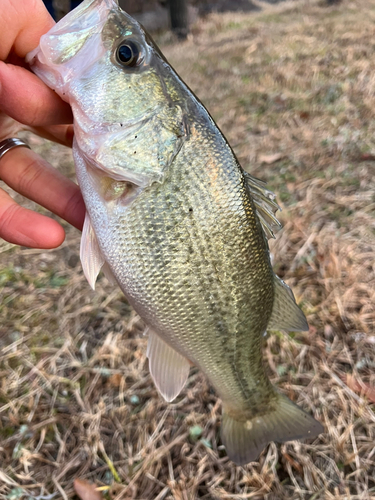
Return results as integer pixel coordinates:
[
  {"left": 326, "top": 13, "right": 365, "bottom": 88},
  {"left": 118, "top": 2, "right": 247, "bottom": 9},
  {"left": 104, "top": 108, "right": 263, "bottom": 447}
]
[{"left": 244, "top": 172, "right": 282, "bottom": 238}]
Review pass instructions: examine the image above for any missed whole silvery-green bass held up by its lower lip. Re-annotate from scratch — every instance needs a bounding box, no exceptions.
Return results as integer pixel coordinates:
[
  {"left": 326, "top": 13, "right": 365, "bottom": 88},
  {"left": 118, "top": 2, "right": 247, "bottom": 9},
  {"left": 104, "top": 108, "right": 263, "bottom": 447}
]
[{"left": 27, "top": 0, "right": 323, "bottom": 465}]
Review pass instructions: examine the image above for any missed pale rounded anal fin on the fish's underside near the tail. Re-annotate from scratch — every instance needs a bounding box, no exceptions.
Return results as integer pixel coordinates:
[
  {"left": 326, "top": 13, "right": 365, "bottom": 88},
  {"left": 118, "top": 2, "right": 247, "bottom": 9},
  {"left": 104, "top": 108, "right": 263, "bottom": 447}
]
[{"left": 147, "top": 330, "right": 190, "bottom": 402}]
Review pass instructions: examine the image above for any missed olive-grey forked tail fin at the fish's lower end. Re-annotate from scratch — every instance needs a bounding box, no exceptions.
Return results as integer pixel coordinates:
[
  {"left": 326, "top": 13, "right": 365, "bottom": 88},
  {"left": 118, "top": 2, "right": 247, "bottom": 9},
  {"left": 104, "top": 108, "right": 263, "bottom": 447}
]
[{"left": 221, "top": 394, "right": 324, "bottom": 465}]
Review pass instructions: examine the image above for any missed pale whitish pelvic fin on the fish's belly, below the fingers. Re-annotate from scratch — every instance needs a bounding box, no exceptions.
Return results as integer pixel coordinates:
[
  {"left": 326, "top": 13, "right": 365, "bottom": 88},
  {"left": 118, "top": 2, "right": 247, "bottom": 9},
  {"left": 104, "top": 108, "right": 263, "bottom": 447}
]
[{"left": 80, "top": 212, "right": 105, "bottom": 290}]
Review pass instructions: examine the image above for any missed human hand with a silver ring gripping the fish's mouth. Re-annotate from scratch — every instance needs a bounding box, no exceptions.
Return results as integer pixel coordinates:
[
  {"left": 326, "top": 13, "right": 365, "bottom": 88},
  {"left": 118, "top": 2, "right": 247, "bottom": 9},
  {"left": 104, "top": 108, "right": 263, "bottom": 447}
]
[{"left": 0, "top": 0, "right": 85, "bottom": 248}]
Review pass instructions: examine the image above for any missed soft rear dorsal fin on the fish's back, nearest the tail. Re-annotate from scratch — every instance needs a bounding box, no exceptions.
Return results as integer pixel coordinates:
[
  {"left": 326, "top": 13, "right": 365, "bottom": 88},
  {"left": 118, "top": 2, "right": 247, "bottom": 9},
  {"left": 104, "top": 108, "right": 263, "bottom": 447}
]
[{"left": 267, "top": 274, "right": 309, "bottom": 332}]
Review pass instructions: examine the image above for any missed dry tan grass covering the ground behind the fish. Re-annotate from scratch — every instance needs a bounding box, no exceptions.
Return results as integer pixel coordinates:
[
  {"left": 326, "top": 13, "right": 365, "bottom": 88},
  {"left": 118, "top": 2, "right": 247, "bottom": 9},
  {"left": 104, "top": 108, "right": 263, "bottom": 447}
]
[{"left": 0, "top": 0, "right": 375, "bottom": 500}]
